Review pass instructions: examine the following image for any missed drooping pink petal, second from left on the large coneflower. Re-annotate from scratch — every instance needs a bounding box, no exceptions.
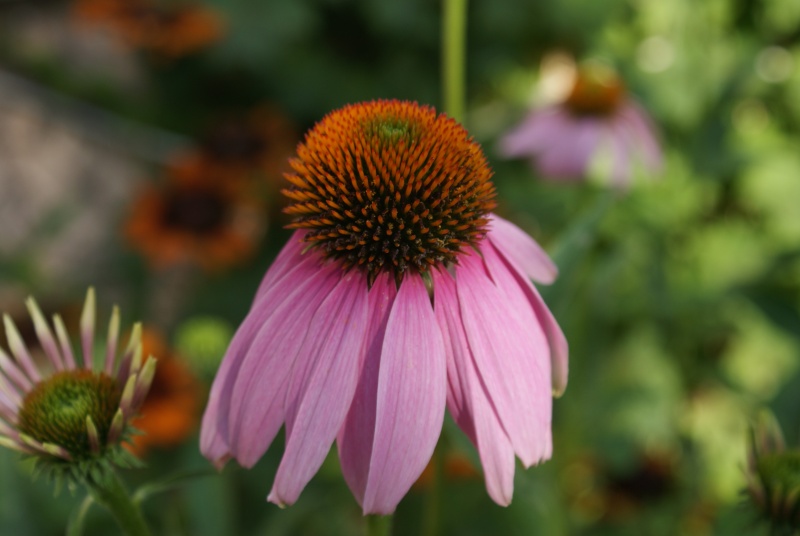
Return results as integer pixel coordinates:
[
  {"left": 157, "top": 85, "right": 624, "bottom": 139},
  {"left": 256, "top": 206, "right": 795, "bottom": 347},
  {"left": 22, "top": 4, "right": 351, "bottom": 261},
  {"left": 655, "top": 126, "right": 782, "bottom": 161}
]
[{"left": 227, "top": 265, "right": 341, "bottom": 467}]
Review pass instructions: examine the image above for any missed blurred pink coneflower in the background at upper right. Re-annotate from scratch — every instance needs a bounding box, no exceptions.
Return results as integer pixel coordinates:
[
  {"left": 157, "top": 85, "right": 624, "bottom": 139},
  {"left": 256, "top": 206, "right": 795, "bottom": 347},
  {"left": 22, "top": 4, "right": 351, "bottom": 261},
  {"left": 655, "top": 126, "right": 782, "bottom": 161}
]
[{"left": 499, "top": 63, "right": 661, "bottom": 187}]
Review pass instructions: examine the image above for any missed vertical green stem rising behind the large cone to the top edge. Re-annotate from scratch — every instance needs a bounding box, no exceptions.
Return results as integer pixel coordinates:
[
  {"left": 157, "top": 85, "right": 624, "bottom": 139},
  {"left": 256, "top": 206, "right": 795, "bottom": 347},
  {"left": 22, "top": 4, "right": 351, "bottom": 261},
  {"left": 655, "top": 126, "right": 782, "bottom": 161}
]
[{"left": 442, "top": 0, "right": 467, "bottom": 123}]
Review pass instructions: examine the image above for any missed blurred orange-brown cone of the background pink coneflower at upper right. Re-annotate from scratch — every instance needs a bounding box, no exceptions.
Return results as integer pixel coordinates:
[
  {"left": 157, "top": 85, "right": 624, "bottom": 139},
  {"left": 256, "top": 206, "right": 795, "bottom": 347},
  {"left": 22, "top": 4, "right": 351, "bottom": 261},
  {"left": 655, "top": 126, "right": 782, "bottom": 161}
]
[{"left": 564, "top": 64, "right": 625, "bottom": 116}]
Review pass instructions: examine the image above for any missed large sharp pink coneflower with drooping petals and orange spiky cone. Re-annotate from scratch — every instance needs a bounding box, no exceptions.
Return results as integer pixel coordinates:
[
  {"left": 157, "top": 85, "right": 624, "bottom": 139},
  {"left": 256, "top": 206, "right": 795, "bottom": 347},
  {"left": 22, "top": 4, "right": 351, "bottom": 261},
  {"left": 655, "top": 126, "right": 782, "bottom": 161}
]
[{"left": 201, "top": 101, "right": 567, "bottom": 514}]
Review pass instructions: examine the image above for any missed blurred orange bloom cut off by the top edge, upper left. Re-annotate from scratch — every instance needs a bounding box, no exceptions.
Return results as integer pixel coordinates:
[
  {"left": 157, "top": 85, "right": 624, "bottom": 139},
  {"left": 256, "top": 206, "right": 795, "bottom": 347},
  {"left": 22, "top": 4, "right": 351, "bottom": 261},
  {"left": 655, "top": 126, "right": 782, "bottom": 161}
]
[{"left": 74, "top": 0, "right": 224, "bottom": 58}]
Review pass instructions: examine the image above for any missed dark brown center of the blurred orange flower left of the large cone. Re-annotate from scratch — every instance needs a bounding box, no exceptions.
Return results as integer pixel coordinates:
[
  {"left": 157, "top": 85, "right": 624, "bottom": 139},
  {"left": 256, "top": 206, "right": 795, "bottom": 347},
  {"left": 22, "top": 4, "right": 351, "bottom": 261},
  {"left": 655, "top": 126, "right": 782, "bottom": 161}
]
[{"left": 163, "top": 189, "right": 227, "bottom": 235}]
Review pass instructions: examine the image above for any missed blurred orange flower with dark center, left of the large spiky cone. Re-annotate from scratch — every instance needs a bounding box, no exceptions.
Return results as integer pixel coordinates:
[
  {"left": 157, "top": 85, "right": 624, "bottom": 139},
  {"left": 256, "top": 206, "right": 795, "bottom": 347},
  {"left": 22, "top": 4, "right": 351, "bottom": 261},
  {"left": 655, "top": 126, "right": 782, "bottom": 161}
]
[{"left": 125, "top": 155, "right": 264, "bottom": 270}]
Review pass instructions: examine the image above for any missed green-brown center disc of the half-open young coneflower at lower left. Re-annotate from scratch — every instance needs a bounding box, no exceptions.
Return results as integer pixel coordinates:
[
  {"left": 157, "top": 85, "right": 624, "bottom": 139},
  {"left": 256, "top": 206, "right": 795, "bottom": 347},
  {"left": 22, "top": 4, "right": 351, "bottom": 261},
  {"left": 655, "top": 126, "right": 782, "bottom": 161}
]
[{"left": 17, "top": 369, "right": 122, "bottom": 460}]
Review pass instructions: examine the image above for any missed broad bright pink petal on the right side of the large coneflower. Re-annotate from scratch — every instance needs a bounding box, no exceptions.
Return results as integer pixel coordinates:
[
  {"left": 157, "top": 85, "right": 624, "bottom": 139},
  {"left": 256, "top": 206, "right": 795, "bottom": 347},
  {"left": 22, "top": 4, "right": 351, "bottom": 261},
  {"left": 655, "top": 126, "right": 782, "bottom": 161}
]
[{"left": 456, "top": 247, "right": 552, "bottom": 467}]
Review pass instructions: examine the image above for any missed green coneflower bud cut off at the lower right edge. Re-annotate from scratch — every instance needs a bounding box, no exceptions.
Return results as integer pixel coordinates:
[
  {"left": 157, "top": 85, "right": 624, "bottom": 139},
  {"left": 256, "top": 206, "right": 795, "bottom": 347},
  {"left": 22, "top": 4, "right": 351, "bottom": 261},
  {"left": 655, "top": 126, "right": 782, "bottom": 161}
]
[{"left": 745, "top": 413, "right": 800, "bottom": 534}]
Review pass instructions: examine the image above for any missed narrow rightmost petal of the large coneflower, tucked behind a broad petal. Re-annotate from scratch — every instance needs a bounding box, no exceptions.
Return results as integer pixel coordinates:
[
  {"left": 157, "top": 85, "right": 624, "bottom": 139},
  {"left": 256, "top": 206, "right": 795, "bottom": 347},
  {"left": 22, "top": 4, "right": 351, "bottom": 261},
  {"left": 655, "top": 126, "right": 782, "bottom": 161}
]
[{"left": 493, "top": 244, "right": 569, "bottom": 397}]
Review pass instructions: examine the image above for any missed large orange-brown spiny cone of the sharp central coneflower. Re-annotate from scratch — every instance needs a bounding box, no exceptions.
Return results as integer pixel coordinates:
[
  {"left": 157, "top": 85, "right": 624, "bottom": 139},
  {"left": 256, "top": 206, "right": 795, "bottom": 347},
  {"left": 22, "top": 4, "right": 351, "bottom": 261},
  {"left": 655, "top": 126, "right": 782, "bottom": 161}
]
[{"left": 284, "top": 100, "right": 495, "bottom": 281}]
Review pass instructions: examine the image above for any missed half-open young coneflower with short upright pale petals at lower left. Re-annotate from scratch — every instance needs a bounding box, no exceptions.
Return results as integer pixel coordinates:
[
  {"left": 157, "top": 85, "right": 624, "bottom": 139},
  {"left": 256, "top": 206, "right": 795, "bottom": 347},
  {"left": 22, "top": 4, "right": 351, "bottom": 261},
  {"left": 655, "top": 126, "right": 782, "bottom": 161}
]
[{"left": 0, "top": 289, "right": 156, "bottom": 483}]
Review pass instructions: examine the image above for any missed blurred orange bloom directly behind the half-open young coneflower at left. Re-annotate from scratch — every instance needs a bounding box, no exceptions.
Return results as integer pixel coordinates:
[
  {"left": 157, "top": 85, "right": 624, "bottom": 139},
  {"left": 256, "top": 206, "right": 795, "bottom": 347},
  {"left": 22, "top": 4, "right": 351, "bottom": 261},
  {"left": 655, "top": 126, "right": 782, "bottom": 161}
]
[{"left": 129, "top": 329, "right": 202, "bottom": 456}]
